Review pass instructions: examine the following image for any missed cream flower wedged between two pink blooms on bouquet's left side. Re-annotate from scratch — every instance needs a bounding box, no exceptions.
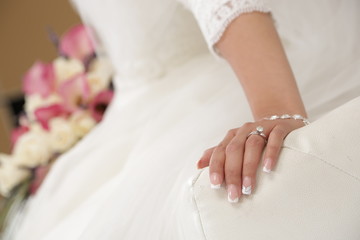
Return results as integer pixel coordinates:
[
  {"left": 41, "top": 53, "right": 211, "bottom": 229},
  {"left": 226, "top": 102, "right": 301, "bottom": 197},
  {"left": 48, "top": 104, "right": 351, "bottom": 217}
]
[{"left": 25, "top": 94, "right": 61, "bottom": 120}]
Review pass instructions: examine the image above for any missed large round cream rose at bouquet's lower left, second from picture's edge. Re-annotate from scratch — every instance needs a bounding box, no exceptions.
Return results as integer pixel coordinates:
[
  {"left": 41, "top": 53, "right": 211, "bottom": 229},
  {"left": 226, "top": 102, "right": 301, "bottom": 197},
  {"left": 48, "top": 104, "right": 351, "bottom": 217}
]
[{"left": 14, "top": 127, "right": 52, "bottom": 168}]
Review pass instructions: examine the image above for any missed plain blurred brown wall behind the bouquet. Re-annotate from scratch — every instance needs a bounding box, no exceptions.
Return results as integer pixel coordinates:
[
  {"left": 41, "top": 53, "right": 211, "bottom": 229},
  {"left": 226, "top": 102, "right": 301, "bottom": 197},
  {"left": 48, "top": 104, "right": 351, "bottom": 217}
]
[{"left": 0, "top": 0, "right": 80, "bottom": 153}]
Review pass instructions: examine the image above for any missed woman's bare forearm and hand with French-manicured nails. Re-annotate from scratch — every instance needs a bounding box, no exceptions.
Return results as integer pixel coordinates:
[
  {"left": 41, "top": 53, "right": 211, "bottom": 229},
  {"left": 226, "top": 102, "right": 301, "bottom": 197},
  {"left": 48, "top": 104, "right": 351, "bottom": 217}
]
[{"left": 198, "top": 12, "right": 306, "bottom": 202}]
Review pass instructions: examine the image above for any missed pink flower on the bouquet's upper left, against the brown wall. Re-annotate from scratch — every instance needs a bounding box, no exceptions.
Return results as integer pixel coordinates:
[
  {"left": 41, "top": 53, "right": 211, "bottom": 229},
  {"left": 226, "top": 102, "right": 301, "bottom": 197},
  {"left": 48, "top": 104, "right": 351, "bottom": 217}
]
[{"left": 23, "top": 62, "right": 56, "bottom": 98}]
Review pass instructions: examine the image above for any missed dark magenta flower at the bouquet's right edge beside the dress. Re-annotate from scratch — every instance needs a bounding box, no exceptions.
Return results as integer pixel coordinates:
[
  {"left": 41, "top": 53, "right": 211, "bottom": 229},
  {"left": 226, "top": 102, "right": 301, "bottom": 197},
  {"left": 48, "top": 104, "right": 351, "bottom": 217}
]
[{"left": 90, "top": 90, "right": 114, "bottom": 122}]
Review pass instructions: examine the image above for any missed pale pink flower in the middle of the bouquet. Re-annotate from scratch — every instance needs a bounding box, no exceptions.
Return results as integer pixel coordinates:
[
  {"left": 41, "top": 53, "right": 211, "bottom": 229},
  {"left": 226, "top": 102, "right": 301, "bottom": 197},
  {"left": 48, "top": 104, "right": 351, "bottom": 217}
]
[{"left": 58, "top": 74, "right": 90, "bottom": 112}]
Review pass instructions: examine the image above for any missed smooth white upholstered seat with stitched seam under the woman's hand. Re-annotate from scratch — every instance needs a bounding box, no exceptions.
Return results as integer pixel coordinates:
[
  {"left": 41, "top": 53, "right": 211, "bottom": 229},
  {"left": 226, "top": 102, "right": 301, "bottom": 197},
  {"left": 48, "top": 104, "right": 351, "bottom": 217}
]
[{"left": 193, "top": 97, "right": 360, "bottom": 240}]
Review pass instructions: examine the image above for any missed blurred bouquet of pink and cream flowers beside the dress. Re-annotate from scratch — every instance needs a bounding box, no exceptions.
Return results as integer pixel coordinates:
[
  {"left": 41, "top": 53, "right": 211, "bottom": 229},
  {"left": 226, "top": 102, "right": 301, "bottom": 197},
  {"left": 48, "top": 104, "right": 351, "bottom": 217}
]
[{"left": 0, "top": 25, "right": 113, "bottom": 231}]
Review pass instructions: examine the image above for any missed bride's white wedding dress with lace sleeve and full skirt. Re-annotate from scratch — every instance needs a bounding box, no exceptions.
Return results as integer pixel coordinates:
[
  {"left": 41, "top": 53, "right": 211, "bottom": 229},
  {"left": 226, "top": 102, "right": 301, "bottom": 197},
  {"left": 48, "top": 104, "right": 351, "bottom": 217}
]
[{"left": 7, "top": 0, "right": 360, "bottom": 240}]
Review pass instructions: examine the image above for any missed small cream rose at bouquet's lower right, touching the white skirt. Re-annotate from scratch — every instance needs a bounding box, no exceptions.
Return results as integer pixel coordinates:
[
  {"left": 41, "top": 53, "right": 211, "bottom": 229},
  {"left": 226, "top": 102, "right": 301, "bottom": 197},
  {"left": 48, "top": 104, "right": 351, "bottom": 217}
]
[{"left": 70, "top": 111, "right": 96, "bottom": 138}]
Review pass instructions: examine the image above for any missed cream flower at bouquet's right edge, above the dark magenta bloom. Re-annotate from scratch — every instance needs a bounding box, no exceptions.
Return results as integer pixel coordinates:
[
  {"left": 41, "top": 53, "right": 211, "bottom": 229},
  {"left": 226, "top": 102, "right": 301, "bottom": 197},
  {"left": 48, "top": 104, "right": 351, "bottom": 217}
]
[{"left": 87, "top": 57, "right": 113, "bottom": 96}]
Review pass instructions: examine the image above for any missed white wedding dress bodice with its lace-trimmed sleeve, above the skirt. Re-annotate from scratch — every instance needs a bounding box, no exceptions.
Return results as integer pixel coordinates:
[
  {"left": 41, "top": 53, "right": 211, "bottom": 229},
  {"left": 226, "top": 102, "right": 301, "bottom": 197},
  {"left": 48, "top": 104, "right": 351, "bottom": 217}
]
[{"left": 72, "top": 0, "right": 269, "bottom": 86}]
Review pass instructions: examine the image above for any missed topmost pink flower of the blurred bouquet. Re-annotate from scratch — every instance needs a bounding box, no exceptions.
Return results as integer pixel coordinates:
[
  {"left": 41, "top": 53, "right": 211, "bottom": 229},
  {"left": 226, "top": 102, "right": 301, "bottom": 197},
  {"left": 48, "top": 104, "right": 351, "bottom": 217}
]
[{"left": 60, "top": 25, "right": 95, "bottom": 61}]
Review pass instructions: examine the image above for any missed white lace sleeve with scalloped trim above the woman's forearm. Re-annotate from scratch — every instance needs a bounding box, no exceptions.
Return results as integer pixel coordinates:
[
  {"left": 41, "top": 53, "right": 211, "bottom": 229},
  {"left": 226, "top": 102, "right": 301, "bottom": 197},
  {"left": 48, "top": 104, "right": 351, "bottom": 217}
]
[{"left": 179, "top": 0, "right": 270, "bottom": 57}]
